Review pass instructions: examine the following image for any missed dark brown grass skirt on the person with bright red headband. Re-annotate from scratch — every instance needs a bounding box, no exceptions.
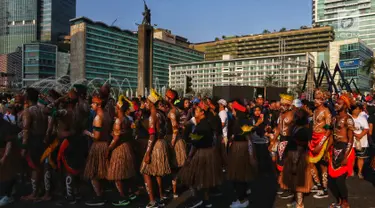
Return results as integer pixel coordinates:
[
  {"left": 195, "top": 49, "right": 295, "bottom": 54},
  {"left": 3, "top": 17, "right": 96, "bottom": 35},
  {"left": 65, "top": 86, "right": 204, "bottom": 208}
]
[{"left": 227, "top": 141, "right": 256, "bottom": 182}]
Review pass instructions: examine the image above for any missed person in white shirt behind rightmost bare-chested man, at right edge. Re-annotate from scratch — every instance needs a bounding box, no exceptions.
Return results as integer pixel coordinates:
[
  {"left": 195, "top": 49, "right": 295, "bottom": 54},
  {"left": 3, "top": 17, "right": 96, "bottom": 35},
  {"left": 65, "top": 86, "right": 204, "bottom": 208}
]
[{"left": 352, "top": 103, "right": 370, "bottom": 179}]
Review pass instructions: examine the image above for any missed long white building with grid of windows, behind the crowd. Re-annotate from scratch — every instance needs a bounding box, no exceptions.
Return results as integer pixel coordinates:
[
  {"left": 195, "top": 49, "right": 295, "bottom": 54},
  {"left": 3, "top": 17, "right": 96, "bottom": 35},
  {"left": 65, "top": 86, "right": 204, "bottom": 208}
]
[{"left": 169, "top": 53, "right": 314, "bottom": 92}]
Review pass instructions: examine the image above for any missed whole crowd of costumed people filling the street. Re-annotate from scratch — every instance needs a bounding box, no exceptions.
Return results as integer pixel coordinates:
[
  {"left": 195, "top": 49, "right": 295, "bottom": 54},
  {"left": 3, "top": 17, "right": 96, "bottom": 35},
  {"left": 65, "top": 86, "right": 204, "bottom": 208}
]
[{"left": 0, "top": 84, "right": 375, "bottom": 208}]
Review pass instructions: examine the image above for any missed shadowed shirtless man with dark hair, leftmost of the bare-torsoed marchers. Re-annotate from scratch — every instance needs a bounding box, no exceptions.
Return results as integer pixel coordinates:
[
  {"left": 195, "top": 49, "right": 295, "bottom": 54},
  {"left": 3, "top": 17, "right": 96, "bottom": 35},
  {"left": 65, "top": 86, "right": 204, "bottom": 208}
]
[{"left": 21, "top": 88, "right": 48, "bottom": 201}]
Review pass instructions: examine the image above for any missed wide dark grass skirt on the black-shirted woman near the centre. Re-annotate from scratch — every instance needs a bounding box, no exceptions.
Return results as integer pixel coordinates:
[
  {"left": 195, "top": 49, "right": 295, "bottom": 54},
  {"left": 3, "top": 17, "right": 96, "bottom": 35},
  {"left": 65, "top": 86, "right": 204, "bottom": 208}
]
[{"left": 177, "top": 147, "right": 223, "bottom": 188}]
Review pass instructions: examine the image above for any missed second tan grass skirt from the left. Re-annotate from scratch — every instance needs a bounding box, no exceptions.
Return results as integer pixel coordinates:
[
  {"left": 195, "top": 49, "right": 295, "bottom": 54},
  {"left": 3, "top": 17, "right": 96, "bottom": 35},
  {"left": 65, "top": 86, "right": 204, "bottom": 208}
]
[{"left": 107, "top": 142, "right": 135, "bottom": 181}]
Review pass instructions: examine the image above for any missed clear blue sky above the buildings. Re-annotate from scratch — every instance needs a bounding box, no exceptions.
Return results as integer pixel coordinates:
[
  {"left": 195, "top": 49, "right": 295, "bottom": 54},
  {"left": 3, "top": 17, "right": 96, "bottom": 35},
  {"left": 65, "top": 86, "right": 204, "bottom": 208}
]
[{"left": 77, "top": 0, "right": 312, "bottom": 43}]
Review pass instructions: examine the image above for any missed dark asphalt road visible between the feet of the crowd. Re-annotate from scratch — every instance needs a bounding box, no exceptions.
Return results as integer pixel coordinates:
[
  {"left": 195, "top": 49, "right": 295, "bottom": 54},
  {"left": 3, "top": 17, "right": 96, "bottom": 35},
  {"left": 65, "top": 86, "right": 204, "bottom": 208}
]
[{"left": 7, "top": 145, "right": 375, "bottom": 208}]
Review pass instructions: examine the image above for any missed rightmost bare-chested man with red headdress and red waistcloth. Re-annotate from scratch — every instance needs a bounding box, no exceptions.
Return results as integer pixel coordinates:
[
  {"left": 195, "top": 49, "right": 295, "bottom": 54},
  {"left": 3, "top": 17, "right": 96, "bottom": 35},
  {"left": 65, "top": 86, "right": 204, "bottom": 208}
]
[{"left": 328, "top": 93, "right": 355, "bottom": 208}]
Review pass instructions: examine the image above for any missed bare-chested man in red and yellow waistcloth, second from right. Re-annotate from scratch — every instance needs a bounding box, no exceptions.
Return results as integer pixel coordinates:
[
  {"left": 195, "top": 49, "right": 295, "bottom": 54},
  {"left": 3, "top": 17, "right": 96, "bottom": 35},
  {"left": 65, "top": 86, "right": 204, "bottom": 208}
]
[{"left": 309, "top": 89, "right": 332, "bottom": 199}]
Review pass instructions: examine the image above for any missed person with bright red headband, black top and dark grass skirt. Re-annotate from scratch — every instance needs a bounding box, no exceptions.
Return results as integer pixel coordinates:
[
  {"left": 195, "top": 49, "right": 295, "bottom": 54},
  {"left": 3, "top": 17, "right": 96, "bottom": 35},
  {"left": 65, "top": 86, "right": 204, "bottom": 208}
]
[{"left": 227, "top": 101, "right": 259, "bottom": 208}]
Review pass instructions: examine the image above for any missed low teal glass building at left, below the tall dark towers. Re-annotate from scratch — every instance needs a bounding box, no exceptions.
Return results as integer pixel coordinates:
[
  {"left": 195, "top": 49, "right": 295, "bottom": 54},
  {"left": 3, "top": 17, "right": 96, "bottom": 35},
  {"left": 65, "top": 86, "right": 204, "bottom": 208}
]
[{"left": 22, "top": 43, "right": 57, "bottom": 87}]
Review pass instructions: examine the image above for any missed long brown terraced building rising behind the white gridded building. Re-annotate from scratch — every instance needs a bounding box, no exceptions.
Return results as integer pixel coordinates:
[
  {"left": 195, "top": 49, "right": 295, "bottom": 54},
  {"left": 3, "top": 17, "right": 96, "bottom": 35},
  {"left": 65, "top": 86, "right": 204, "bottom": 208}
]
[{"left": 190, "top": 26, "right": 334, "bottom": 61}]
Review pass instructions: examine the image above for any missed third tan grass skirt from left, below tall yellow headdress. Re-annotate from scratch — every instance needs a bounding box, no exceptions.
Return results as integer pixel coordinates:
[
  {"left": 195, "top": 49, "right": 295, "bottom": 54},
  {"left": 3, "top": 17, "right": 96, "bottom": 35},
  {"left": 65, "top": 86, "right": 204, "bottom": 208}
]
[{"left": 140, "top": 139, "right": 171, "bottom": 176}]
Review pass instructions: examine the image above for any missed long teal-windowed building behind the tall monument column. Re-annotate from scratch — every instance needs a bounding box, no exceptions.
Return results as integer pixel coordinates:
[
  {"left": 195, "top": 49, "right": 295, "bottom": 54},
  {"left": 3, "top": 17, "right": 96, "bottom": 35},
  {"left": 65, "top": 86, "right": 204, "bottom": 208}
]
[{"left": 70, "top": 17, "right": 204, "bottom": 90}]
